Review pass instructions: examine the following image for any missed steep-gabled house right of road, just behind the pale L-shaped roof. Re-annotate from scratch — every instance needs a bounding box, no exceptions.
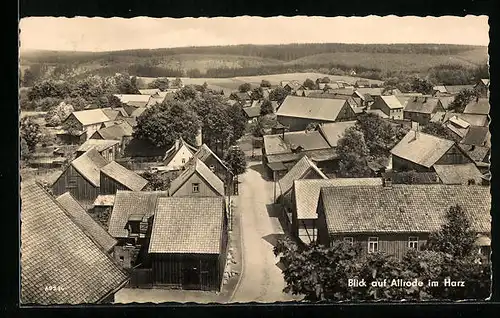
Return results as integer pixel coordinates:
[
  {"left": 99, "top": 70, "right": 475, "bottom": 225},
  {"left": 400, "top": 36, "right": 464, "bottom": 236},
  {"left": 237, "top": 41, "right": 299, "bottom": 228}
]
[{"left": 277, "top": 155, "right": 328, "bottom": 203}]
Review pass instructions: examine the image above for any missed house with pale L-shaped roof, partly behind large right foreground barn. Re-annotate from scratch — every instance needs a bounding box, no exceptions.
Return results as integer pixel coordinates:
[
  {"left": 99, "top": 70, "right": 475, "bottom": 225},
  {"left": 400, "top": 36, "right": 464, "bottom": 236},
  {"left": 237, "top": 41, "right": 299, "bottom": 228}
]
[{"left": 285, "top": 178, "right": 382, "bottom": 244}]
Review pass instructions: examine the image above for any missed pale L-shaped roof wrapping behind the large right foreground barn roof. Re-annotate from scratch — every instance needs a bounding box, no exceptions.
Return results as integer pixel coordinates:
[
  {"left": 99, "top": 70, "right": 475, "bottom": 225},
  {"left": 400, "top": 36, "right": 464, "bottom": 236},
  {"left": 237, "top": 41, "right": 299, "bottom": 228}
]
[{"left": 293, "top": 178, "right": 382, "bottom": 219}]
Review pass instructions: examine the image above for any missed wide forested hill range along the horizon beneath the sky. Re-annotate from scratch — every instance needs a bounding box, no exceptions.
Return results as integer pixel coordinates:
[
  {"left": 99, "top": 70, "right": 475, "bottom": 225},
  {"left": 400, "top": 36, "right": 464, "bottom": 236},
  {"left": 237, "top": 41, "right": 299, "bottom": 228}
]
[{"left": 20, "top": 43, "right": 488, "bottom": 84}]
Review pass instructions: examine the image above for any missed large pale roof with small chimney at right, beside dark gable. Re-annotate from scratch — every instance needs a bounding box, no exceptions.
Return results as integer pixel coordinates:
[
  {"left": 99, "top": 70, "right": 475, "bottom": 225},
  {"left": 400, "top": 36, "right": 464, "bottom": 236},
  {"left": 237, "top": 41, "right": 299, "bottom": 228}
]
[{"left": 391, "top": 130, "right": 455, "bottom": 168}]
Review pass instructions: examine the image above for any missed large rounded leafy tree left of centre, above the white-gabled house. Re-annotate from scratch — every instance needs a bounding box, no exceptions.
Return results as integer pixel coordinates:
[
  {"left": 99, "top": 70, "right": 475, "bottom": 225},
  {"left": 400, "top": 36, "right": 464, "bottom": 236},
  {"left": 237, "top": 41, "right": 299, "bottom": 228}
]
[{"left": 134, "top": 100, "right": 200, "bottom": 147}]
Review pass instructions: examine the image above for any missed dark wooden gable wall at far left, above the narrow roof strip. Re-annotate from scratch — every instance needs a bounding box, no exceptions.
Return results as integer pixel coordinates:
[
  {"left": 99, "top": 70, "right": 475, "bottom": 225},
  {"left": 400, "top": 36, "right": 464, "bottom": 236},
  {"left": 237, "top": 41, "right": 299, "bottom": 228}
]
[{"left": 52, "top": 165, "right": 99, "bottom": 202}]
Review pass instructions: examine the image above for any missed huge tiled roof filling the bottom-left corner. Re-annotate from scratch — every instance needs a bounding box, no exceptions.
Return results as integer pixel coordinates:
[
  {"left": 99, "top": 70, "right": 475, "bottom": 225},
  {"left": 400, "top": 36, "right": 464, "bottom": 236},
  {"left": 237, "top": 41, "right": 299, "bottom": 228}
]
[{"left": 21, "top": 183, "right": 127, "bottom": 305}]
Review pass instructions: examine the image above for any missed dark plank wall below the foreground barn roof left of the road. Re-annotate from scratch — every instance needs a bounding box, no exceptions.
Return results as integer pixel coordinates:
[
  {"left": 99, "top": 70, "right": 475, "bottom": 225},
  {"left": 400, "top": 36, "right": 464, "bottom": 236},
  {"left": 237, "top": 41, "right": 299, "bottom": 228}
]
[{"left": 151, "top": 253, "right": 221, "bottom": 291}]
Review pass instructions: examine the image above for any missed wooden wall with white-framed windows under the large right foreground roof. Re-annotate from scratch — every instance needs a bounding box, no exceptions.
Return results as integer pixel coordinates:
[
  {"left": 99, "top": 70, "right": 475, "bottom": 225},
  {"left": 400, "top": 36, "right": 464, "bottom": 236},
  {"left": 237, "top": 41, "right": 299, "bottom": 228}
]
[{"left": 330, "top": 233, "right": 429, "bottom": 259}]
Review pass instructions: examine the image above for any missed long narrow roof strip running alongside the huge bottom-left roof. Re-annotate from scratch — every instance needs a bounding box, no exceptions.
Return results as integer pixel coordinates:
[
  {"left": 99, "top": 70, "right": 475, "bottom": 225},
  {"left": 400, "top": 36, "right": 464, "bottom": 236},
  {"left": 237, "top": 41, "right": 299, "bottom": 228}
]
[{"left": 56, "top": 192, "right": 117, "bottom": 252}]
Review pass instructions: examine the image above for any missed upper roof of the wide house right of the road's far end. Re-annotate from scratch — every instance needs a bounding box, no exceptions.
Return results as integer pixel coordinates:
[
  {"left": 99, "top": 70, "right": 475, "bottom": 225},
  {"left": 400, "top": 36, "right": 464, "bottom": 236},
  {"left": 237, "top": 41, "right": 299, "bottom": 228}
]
[{"left": 264, "top": 130, "right": 331, "bottom": 155}]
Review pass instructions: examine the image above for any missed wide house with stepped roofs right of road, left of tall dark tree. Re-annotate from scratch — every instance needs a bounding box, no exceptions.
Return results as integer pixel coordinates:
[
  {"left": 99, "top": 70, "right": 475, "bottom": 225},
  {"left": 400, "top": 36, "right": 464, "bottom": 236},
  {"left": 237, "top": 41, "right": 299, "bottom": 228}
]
[{"left": 262, "top": 130, "right": 337, "bottom": 180}]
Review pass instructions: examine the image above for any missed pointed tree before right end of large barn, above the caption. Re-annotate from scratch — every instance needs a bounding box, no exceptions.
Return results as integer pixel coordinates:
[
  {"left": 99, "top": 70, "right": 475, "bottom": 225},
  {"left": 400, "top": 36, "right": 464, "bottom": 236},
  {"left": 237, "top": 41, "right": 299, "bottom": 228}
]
[{"left": 427, "top": 205, "right": 476, "bottom": 258}]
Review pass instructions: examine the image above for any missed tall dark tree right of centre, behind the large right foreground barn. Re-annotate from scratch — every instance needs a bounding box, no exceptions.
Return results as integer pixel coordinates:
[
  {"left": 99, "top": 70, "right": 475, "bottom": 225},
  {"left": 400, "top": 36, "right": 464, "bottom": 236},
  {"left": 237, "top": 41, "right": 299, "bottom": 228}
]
[{"left": 337, "top": 127, "right": 371, "bottom": 178}]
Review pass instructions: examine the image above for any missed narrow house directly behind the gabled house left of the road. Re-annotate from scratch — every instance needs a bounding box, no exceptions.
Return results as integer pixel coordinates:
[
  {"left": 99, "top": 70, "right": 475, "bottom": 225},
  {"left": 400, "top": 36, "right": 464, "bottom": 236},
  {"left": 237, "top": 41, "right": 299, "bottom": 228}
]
[{"left": 189, "top": 144, "right": 238, "bottom": 195}]
